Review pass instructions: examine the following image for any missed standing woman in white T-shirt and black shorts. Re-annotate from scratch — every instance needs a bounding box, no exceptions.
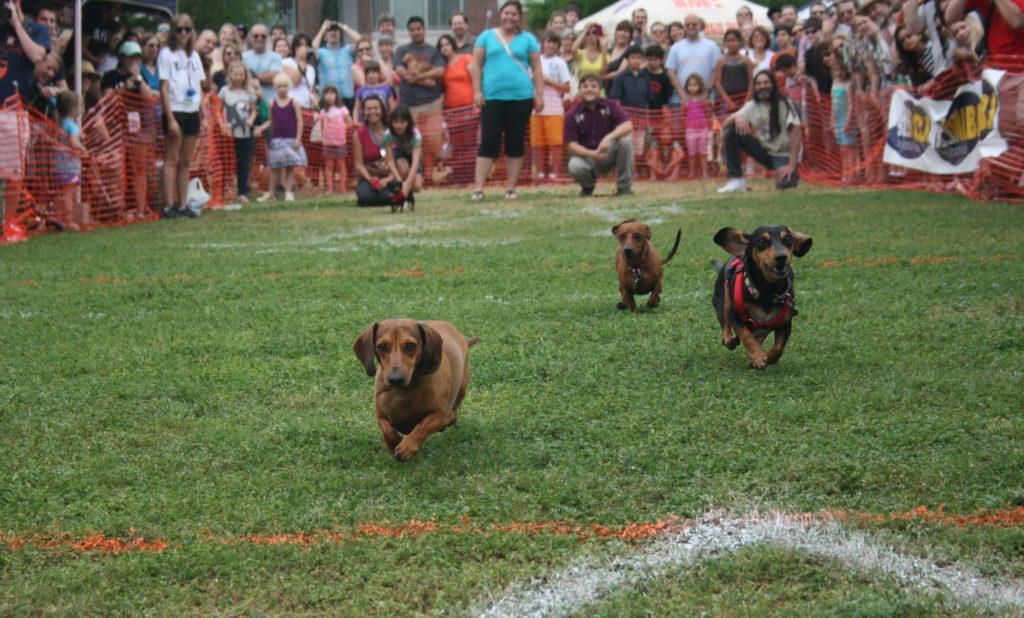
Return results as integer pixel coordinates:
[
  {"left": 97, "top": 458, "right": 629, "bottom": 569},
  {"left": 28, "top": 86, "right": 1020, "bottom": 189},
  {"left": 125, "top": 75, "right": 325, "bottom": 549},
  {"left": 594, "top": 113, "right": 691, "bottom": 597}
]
[{"left": 157, "top": 13, "right": 206, "bottom": 219}]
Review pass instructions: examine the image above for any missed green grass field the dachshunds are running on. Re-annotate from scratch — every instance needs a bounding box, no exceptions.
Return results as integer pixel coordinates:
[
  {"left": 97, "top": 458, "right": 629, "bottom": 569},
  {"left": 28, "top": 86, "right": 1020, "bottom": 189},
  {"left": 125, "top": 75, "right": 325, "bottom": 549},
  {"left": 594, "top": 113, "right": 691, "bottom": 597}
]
[{"left": 0, "top": 183, "right": 1024, "bottom": 616}]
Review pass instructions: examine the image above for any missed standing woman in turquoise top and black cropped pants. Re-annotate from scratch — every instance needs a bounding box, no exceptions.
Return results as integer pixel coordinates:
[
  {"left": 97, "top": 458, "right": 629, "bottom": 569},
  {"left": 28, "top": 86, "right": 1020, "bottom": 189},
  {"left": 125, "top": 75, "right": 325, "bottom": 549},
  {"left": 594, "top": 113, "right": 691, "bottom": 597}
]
[{"left": 469, "top": 0, "right": 544, "bottom": 201}]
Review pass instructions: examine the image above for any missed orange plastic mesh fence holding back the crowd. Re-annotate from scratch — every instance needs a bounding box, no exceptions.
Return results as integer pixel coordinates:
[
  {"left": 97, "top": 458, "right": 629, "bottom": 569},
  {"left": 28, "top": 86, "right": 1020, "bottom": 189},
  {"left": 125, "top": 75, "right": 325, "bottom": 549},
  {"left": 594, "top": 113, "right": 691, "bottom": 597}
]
[{"left": 0, "top": 58, "right": 1024, "bottom": 241}]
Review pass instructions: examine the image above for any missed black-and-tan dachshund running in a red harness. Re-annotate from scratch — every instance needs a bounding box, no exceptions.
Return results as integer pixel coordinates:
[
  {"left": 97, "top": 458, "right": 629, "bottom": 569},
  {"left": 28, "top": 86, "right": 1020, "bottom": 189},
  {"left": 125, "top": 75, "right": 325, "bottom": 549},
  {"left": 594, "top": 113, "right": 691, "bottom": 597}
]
[{"left": 712, "top": 225, "right": 812, "bottom": 369}]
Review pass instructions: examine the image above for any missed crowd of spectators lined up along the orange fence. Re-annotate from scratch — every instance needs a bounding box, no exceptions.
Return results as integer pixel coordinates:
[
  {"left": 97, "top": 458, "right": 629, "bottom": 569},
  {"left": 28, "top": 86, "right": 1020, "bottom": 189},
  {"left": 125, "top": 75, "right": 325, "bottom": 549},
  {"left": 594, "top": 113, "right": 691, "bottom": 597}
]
[{"left": 0, "top": 0, "right": 1024, "bottom": 218}]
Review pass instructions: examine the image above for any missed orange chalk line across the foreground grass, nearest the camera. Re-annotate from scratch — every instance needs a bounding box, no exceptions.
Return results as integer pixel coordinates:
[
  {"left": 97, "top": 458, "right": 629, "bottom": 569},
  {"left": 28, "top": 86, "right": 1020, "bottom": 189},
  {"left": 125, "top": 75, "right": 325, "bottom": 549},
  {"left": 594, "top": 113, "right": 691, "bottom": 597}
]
[{"left": 8, "top": 506, "right": 1024, "bottom": 556}]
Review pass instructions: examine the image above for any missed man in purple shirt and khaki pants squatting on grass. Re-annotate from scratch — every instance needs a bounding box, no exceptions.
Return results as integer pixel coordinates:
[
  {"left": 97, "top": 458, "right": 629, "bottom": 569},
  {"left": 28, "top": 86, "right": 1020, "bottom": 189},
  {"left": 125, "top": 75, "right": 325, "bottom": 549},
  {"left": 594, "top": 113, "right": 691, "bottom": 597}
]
[{"left": 565, "top": 73, "right": 633, "bottom": 197}]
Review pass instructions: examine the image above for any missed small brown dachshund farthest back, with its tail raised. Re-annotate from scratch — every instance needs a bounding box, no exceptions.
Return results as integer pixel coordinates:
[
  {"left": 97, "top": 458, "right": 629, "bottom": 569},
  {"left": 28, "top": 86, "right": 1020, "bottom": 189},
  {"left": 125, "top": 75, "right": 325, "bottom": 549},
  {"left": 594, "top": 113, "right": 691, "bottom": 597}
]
[{"left": 611, "top": 219, "right": 683, "bottom": 311}]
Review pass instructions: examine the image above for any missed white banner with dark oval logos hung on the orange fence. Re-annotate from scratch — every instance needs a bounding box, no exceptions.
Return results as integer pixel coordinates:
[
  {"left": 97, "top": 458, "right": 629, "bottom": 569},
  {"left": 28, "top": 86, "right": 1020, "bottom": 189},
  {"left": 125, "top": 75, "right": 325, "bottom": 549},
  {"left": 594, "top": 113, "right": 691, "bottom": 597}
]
[{"left": 883, "top": 69, "right": 1007, "bottom": 174}]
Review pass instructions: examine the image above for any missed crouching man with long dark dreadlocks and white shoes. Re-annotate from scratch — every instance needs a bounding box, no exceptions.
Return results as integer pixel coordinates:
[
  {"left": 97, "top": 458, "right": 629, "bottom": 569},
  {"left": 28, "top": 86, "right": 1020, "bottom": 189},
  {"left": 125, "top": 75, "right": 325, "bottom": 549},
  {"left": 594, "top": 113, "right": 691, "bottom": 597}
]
[{"left": 718, "top": 71, "right": 802, "bottom": 193}]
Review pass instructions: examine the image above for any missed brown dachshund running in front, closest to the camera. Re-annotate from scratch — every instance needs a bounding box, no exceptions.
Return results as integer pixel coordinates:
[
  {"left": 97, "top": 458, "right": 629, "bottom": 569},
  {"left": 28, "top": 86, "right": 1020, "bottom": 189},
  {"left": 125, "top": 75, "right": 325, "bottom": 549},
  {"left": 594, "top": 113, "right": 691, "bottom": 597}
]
[{"left": 352, "top": 319, "right": 479, "bottom": 461}]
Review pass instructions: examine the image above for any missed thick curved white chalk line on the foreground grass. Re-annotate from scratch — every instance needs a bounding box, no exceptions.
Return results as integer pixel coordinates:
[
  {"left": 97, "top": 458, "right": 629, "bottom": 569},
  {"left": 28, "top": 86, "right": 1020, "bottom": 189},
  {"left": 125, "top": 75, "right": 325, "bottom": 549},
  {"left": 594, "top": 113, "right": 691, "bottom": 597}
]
[{"left": 474, "top": 516, "right": 1024, "bottom": 618}]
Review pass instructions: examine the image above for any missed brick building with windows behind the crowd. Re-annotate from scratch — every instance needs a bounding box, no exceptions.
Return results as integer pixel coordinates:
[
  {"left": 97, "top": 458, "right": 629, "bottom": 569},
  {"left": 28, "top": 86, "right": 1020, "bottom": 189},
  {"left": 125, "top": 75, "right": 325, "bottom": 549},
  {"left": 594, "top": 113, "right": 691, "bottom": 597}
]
[{"left": 276, "top": 0, "right": 500, "bottom": 42}]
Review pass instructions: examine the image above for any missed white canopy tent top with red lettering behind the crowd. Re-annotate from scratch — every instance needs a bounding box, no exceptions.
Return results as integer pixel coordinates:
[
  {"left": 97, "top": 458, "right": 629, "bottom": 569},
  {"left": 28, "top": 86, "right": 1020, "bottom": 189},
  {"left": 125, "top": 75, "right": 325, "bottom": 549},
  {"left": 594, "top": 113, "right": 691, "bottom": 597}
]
[{"left": 575, "top": 0, "right": 771, "bottom": 39}]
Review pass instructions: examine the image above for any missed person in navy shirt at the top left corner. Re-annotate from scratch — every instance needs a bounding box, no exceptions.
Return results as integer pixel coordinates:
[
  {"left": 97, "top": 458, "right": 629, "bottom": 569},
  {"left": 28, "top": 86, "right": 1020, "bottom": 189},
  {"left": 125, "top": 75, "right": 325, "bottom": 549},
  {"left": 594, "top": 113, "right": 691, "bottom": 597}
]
[{"left": 0, "top": 0, "right": 50, "bottom": 102}]
